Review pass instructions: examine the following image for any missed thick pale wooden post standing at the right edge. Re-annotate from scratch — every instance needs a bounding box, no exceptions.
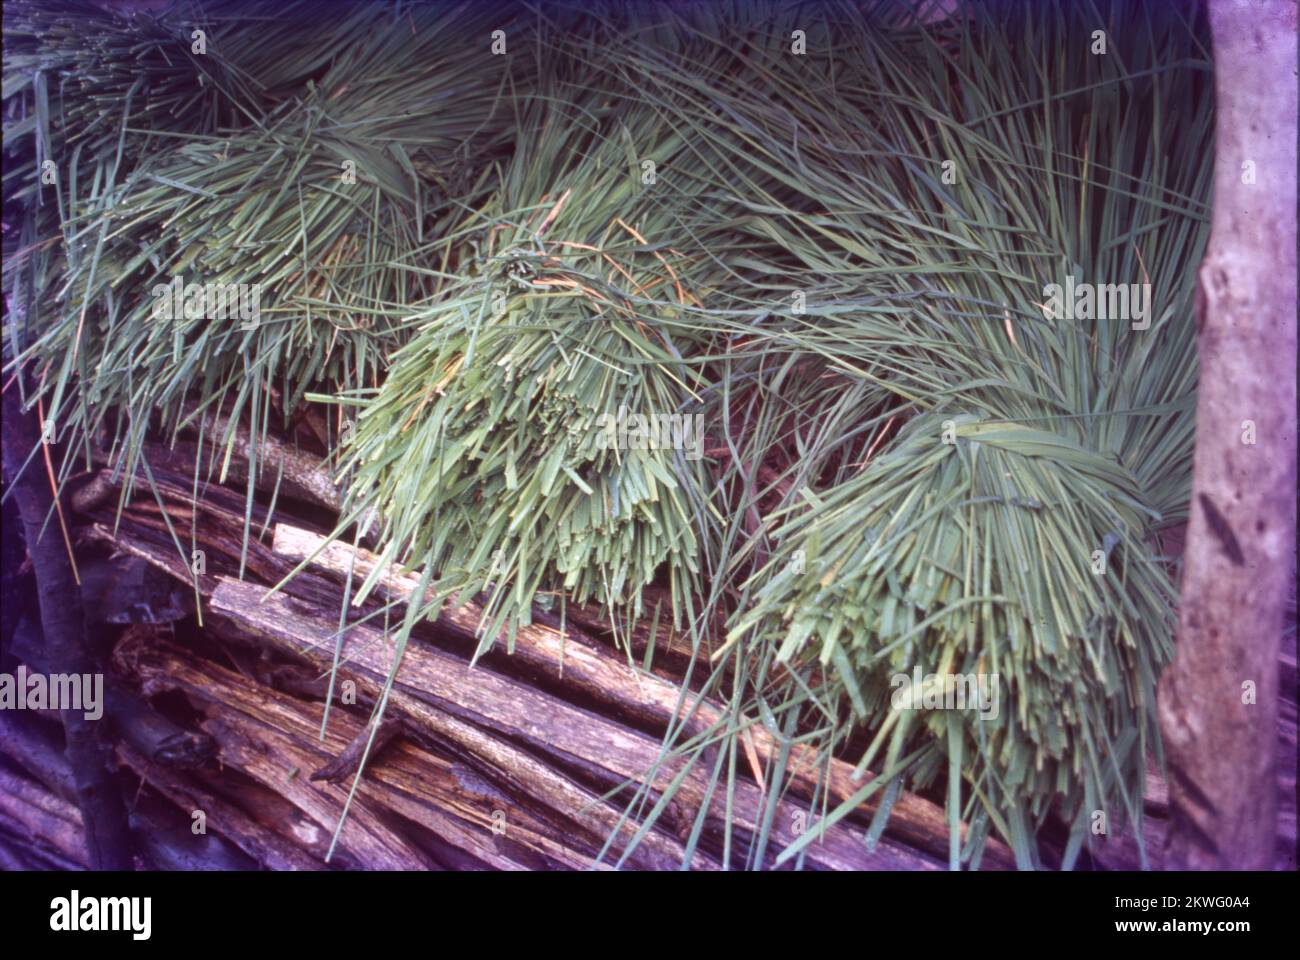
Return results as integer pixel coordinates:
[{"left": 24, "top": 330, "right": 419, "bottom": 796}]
[{"left": 1160, "top": 0, "right": 1296, "bottom": 869}]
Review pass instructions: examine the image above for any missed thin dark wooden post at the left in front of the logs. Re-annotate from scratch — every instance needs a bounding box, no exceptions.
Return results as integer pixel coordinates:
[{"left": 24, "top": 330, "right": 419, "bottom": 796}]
[{"left": 0, "top": 382, "right": 134, "bottom": 870}]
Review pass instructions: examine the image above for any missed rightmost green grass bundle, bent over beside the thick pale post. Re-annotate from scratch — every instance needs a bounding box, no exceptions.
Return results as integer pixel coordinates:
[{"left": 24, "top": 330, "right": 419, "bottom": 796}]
[{"left": 605, "top": 0, "right": 1210, "bottom": 866}]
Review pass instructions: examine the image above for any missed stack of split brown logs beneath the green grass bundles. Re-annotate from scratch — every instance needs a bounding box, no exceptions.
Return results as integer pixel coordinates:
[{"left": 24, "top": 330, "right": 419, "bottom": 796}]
[{"left": 0, "top": 418, "right": 1296, "bottom": 870}]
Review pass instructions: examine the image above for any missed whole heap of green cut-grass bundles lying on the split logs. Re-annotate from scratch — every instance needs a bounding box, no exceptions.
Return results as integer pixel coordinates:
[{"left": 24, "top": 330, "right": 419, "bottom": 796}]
[{"left": 4, "top": 3, "right": 1212, "bottom": 868}]
